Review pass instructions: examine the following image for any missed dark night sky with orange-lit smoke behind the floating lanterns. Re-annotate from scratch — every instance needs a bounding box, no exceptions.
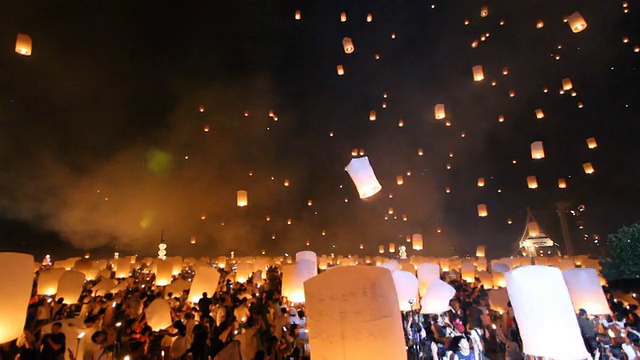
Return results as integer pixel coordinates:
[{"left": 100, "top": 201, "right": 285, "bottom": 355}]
[{"left": 0, "top": 0, "right": 640, "bottom": 257}]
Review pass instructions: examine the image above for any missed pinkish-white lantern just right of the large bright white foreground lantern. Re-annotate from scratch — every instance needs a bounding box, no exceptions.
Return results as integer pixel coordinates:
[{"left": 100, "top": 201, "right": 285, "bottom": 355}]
[{"left": 562, "top": 268, "right": 611, "bottom": 315}]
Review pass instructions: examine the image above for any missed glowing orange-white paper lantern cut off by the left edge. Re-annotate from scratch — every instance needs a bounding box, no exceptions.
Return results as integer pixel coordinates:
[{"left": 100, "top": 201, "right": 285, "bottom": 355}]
[{"left": 0, "top": 252, "right": 33, "bottom": 344}]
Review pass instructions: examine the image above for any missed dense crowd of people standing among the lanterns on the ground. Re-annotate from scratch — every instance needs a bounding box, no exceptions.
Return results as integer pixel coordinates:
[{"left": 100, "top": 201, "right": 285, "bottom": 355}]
[{"left": 0, "top": 267, "right": 640, "bottom": 360}]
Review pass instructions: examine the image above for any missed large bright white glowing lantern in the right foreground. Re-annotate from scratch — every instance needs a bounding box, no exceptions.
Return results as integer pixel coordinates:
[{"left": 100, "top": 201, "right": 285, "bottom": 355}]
[{"left": 506, "top": 265, "right": 590, "bottom": 359}]
